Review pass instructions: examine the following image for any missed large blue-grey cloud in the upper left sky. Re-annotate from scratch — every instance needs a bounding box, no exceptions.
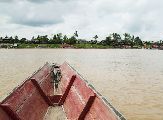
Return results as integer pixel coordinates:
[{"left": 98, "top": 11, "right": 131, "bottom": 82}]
[{"left": 1, "top": 0, "right": 63, "bottom": 27}]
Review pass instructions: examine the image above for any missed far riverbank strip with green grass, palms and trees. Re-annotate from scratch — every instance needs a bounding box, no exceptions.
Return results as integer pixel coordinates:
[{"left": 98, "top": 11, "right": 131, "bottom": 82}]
[{"left": 0, "top": 31, "right": 163, "bottom": 49}]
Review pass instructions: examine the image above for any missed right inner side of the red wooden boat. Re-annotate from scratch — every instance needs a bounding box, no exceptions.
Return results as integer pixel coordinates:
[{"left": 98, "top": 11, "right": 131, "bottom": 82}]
[{"left": 60, "top": 63, "right": 118, "bottom": 120}]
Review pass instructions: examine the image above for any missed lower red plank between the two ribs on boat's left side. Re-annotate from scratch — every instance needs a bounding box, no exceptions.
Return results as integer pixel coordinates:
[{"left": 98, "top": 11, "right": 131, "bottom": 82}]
[{"left": 16, "top": 89, "right": 49, "bottom": 120}]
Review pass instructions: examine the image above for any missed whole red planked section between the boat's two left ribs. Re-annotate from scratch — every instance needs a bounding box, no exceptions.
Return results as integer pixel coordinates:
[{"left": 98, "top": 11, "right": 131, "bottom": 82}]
[{"left": 2, "top": 81, "right": 49, "bottom": 120}]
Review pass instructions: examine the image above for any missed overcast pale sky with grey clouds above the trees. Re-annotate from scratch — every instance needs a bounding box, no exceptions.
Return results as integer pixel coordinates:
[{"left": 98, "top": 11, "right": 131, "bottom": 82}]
[{"left": 0, "top": 0, "right": 163, "bottom": 41}]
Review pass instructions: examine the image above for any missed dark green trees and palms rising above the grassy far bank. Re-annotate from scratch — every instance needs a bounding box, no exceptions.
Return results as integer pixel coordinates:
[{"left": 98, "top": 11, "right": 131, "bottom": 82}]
[{"left": 0, "top": 31, "right": 163, "bottom": 48}]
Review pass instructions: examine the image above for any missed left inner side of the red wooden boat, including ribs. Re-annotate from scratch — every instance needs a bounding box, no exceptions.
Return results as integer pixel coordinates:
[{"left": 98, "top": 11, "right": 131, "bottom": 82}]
[{"left": 0, "top": 63, "right": 54, "bottom": 120}]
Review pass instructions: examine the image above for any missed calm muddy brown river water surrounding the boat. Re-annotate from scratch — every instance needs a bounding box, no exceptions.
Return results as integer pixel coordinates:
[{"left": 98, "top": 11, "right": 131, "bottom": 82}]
[{"left": 0, "top": 49, "right": 163, "bottom": 120}]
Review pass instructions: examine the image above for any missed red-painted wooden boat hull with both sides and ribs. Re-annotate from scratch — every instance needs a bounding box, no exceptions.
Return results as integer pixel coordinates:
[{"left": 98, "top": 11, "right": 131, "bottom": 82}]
[{"left": 0, "top": 62, "right": 125, "bottom": 120}]
